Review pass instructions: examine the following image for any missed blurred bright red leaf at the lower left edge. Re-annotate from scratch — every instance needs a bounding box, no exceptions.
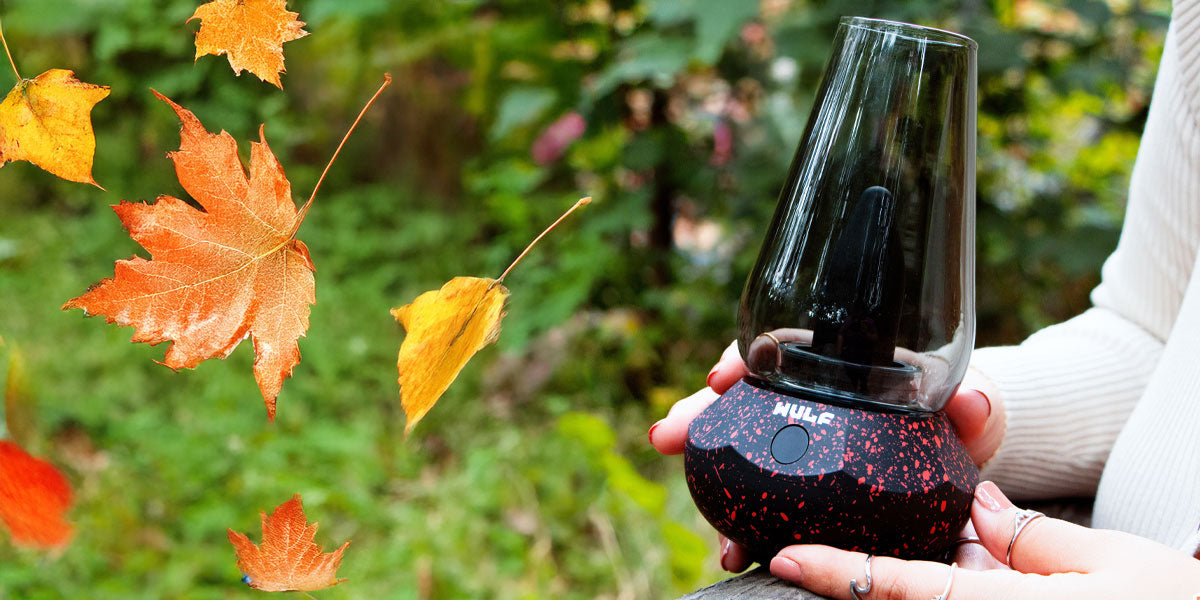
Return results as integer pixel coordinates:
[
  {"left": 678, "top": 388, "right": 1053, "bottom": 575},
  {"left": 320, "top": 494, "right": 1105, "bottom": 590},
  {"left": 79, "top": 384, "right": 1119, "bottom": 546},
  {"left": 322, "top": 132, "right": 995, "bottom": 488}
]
[{"left": 0, "top": 439, "right": 71, "bottom": 548}]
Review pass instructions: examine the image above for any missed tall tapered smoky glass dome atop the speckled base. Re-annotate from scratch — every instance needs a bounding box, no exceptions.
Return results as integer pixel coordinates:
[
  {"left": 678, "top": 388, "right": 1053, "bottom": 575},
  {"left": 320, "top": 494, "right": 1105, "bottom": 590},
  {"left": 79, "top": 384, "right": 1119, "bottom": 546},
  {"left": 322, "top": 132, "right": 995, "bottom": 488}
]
[{"left": 738, "top": 18, "right": 977, "bottom": 412}]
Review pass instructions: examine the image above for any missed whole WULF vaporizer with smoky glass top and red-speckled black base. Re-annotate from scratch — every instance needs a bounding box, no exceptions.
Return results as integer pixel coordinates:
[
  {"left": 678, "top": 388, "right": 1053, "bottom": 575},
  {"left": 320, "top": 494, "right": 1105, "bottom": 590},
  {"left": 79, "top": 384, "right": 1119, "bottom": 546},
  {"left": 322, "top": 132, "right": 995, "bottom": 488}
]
[{"left": 685, "top": 18, "right": 979, "bottom": 562}]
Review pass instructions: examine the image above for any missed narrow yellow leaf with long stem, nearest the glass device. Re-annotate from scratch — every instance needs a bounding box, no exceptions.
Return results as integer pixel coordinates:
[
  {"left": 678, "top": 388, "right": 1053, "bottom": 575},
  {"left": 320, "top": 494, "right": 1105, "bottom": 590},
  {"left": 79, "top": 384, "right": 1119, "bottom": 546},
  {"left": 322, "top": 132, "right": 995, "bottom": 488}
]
[{"left": 391, "top": 197, "right": 592, "bottom": 434}]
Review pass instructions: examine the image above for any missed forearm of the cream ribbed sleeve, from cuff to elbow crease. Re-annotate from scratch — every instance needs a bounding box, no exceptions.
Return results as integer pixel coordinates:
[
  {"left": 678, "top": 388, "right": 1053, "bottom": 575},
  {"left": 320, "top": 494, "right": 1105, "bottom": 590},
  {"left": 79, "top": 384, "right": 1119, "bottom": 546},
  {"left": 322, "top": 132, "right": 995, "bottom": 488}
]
[{"left": 964, "top": 307, "right": 1163, "bottom": 499}]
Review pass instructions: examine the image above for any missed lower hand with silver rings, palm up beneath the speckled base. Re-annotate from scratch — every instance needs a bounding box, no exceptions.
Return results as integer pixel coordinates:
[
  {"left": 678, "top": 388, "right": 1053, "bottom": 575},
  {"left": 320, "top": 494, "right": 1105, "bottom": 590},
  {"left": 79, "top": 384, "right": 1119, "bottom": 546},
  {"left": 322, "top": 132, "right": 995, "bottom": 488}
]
[{"left": 770, "top": 481, "right": 1200, "bottom": 600}]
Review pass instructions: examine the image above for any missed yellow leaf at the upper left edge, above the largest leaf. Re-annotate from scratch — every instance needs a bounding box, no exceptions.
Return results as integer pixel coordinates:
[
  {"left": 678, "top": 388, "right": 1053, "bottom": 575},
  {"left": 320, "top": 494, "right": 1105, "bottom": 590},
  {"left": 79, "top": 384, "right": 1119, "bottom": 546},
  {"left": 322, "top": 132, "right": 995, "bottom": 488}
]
[{"left": 0, "top": 68, "right": 108, "bottom": 187}]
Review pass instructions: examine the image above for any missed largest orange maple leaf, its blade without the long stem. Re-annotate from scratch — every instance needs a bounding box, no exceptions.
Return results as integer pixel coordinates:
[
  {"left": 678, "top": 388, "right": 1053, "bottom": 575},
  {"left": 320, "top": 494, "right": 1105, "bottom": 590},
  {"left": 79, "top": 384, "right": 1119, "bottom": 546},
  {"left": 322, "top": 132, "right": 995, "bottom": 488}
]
[{"left": 62, "top": 91, "right": 317, "bottom": 419}]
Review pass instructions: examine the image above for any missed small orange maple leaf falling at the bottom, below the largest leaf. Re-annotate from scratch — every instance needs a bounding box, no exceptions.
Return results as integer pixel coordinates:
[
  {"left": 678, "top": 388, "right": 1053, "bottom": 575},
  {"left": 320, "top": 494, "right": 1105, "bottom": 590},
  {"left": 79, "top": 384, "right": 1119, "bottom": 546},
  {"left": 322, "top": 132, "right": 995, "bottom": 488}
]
[{"left": 228, "top": 494, "right": 350, "bottom": 592}]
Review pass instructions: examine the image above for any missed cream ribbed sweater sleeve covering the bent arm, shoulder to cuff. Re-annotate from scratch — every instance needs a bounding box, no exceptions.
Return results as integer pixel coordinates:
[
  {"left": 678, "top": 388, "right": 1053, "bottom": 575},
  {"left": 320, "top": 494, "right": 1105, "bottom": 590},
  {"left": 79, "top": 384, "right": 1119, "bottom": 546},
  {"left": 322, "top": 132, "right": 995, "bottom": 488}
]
[{"left": 971, "top": 21, "right": 1200, "bottom": 499}]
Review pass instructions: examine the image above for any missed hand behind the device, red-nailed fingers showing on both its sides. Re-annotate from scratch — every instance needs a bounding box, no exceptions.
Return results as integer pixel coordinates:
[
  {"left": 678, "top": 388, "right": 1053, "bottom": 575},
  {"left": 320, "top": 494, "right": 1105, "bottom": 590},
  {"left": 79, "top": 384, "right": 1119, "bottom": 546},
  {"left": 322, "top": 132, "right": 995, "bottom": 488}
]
[{"left": 649, "top": 342, "right": 1004, "bottom": 572}]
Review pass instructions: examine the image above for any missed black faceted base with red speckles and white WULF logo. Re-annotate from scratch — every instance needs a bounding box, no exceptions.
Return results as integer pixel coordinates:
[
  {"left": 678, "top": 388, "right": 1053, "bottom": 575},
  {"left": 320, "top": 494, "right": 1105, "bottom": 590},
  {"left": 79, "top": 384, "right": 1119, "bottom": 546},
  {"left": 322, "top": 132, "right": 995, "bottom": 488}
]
[{"left": 684, "top": 380, "right": 979, "bottom": 564}]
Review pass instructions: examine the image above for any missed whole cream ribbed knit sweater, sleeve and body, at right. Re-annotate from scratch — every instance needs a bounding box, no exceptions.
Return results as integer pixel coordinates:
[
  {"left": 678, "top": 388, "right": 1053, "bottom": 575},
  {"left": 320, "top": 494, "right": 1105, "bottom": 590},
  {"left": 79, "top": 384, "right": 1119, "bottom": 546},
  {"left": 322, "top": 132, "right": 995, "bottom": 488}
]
[{"left": 971, "top": 7, "right": 1200, "bottom": 553}]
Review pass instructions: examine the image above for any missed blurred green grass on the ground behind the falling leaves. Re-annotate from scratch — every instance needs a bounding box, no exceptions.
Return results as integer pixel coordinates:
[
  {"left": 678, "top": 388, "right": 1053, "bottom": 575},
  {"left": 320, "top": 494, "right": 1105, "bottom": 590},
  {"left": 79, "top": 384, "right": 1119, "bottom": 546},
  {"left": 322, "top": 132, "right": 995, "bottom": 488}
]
[{"left": 0, "top": 181, "right": 719, "bottom": 599}]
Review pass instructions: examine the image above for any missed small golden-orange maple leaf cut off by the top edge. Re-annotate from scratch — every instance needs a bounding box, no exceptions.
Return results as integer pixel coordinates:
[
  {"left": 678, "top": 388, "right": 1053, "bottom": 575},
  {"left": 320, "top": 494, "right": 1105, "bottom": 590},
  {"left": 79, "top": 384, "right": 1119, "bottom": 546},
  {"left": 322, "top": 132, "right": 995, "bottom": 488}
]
[{"left": 187, "top": 0, "right": 308, "bottom": 89}]
